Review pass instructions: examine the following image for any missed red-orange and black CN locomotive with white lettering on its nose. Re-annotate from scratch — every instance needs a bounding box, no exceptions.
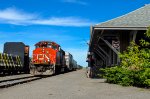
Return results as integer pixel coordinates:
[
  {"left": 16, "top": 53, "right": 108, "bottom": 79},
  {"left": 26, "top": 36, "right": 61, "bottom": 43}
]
[{"left": 30, "top": 41, "right": 77, "bottom": 75}]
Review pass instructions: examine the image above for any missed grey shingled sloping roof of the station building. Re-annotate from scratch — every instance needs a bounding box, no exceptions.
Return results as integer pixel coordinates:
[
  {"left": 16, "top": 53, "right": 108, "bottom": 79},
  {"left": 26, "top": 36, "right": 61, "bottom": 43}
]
[{"left": 94, "top": 4, "right": 150, "bottom": 28}]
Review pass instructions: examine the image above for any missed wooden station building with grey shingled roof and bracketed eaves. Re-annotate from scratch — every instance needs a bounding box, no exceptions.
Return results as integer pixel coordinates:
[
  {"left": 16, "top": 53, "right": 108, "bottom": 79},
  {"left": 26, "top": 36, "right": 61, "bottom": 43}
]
[{"left": 87, "top": 4, "right": 150, "bottom": 75}]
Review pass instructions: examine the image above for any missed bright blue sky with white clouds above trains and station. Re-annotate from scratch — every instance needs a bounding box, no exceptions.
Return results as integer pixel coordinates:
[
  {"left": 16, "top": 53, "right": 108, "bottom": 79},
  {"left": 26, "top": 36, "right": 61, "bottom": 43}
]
[{"left": 0, "top": 0, "right": 150, "bottom": 66}]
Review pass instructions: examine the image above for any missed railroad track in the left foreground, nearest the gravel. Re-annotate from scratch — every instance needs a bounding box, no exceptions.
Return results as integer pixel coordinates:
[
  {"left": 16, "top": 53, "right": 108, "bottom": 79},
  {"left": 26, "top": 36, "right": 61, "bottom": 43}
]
[{"left": 0, "top": 76, "right": 42, "bottom": 88}]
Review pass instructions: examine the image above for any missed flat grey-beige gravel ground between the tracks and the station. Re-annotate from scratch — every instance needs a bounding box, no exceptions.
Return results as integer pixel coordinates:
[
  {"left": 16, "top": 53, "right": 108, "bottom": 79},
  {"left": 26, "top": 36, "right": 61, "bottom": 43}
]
[{"left": 0, "top": 70, "right": 150, "bottom": 99}]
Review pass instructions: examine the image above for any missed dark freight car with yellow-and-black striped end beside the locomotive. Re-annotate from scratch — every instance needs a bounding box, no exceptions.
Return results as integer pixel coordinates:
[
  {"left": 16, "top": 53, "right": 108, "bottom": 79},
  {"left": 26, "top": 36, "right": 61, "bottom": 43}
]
[{"left": 0, "top": 42, "right": 29, "bottom": 74}]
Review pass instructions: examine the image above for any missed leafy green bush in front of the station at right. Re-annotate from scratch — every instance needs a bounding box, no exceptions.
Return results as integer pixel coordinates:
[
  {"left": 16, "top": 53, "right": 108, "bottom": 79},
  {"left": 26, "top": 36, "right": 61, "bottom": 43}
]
[{"left": 101, "top": 28, "right": 150, "bottom": 87}]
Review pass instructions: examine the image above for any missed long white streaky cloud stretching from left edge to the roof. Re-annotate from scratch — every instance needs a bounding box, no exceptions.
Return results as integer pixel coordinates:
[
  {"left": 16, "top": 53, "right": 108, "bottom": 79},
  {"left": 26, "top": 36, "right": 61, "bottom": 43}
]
[{"left": 0, "top": 8, "right": 93, "bottom": 27}]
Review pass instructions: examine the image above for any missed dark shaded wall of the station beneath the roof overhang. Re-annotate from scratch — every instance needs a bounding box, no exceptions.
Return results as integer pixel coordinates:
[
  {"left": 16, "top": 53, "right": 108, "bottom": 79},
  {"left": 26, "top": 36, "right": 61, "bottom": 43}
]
[{"left": 89, "top": 30, "right": 145, "bottom": 68}]
